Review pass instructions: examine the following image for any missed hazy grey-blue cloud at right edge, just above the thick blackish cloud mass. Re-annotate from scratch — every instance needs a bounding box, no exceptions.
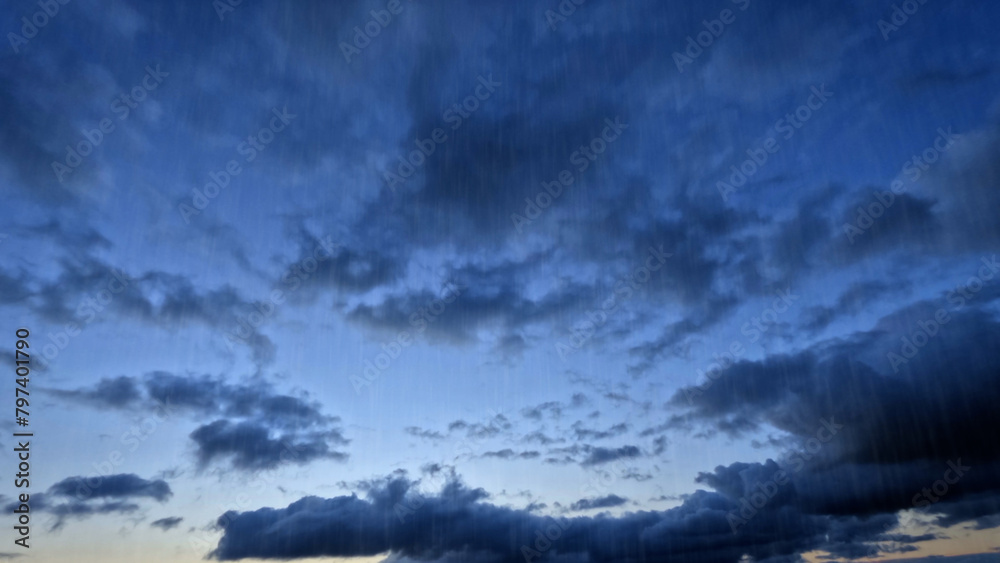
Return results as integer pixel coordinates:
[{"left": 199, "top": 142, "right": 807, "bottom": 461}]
[{"left": 804, "top": 116, "right": 1000, "bottom": 267}]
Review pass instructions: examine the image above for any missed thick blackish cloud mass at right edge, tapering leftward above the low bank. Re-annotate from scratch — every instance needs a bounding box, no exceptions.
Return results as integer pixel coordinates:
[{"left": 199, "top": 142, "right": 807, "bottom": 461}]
[{"left": 671, "top": 295, "right": 1000, "bottom": 462}]
